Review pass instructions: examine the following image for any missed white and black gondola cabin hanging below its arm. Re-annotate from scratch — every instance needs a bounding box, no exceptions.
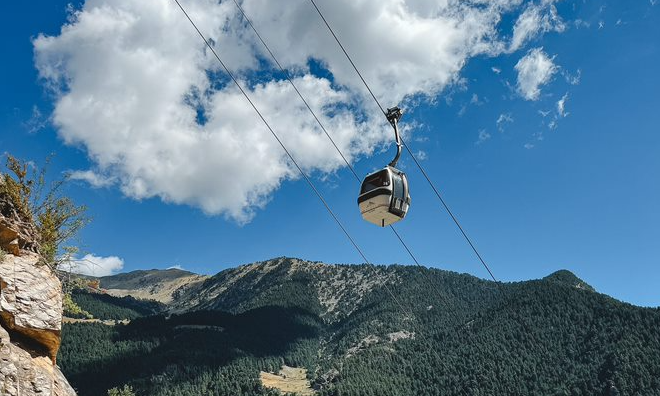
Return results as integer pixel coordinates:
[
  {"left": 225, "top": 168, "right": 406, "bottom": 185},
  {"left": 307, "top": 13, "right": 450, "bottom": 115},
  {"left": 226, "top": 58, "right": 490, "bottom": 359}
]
[{"left": 358, "top": 166, "right": 410, "bottom": 227}]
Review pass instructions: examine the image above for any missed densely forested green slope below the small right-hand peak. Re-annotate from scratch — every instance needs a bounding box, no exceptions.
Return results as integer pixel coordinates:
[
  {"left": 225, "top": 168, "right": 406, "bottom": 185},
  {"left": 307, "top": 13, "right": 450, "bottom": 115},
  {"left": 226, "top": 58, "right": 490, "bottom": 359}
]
[{"left": 322, "top": 274, "right": 660, "bottom": 396}]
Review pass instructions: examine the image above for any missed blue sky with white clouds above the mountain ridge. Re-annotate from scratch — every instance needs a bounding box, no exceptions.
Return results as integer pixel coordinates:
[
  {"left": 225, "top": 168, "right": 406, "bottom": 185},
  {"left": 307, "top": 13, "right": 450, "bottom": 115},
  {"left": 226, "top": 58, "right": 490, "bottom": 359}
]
[{"left": 0, "top": 0, "right": 660, "bottom": 306}]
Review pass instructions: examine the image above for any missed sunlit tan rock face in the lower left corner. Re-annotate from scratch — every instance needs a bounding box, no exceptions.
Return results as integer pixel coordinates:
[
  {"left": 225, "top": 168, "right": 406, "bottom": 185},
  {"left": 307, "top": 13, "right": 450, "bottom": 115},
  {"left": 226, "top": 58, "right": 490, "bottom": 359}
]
[{"left": 0, "top": 253, "right": 76, "bottom": 396}]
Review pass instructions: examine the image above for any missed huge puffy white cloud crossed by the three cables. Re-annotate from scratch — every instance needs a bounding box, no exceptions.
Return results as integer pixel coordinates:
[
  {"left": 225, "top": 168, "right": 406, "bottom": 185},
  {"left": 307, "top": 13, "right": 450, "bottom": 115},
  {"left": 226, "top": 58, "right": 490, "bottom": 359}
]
[{"left": 33, "top": 0, "right": 556, "bottom": 223}]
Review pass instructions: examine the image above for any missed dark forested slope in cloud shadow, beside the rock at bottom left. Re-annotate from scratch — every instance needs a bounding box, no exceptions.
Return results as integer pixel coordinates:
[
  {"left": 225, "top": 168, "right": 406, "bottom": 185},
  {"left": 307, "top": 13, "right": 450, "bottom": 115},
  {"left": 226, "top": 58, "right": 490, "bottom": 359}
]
[{"left": 59, "top": 307, "right": 320, "bottom": 396}]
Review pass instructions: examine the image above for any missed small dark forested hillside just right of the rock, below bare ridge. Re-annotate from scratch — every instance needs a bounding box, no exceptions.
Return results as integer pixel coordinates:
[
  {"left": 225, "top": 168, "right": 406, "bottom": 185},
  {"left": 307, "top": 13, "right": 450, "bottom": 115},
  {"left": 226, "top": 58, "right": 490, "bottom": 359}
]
[{"left": 71, "top": 290, "right": 163, "bottom": 320}]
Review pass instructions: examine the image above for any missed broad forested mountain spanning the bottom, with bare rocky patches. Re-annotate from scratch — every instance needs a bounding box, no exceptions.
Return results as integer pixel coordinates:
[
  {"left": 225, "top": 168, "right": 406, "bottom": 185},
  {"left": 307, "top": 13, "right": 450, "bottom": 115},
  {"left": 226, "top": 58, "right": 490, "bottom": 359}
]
[{"left": 59, "top": 258, "right": 660, "bottom": 396}]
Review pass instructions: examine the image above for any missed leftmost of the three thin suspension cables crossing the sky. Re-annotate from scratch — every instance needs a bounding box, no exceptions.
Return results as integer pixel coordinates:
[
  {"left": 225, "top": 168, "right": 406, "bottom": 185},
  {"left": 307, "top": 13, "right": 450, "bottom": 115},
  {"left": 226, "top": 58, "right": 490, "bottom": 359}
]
[{"left": 174, "top": 0, "right": 414, "bottom": 318}]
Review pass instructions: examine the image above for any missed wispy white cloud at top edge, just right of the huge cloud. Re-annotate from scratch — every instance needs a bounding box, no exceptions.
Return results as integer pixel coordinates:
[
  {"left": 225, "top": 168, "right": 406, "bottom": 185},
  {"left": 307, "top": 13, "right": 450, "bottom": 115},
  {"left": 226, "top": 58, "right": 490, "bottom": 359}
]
[{"left": 509, "top": 0, "right": 566, "bottom": 52}]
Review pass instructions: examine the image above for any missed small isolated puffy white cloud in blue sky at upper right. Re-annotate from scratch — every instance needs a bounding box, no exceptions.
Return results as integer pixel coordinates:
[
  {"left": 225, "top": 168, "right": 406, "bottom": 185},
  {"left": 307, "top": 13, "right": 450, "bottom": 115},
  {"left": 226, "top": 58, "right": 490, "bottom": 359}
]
[{"left": 515, "top": 48, "right": 558, "bottom": 100}]
